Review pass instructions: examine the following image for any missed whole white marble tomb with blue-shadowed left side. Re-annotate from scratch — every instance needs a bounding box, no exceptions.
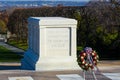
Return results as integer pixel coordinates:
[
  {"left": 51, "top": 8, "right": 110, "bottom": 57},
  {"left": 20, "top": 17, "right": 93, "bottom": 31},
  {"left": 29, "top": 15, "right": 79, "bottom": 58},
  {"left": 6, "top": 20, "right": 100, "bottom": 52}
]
[{"left": 21, "top": 17, "right": 80, "bottom": 71}]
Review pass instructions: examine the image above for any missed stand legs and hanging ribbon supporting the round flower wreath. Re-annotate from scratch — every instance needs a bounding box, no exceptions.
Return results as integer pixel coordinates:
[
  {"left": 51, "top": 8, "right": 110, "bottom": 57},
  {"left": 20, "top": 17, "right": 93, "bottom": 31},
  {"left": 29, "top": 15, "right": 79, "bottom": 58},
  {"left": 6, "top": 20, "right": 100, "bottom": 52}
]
[{"left": 83, "top": 53, "right": 100, "bottom": 80}]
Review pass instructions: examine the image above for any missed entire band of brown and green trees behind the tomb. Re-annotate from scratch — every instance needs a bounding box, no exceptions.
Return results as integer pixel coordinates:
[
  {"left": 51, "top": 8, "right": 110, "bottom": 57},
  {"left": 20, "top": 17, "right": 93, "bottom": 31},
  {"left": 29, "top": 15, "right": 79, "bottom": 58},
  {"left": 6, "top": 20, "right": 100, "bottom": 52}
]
[{"left": 7, "top": 1, "right": 120, "bottom": 59}]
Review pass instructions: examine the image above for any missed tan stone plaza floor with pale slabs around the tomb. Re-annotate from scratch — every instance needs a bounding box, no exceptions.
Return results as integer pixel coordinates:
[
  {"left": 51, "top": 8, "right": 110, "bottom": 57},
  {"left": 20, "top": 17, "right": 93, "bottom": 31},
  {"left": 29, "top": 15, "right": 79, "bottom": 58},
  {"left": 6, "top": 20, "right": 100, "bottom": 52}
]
[{"left": 0, "top": 61, "right": 120, "bottom": 80}]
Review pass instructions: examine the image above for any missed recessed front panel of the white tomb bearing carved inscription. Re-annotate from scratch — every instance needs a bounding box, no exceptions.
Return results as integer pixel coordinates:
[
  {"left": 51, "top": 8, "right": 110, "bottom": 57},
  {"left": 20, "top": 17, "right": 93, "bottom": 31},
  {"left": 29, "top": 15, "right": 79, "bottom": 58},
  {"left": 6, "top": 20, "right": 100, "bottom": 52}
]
[{"left": 46, "top": 28, "right": 70, "bottom": 55}]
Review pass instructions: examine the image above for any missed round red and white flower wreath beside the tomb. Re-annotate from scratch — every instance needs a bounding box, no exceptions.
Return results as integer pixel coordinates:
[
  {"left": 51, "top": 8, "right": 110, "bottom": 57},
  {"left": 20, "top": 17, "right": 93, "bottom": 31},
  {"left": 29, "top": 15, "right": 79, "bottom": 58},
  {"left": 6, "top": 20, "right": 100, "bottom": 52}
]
[{"left": 77, "top": 47, "right": 99, "bottom": 71}]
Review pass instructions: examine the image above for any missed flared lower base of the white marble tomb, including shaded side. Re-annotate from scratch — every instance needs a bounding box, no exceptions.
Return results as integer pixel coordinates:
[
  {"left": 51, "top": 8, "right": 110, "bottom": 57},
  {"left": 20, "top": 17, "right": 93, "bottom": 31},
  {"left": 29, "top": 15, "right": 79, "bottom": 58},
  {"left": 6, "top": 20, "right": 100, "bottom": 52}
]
[{"left": 21, "top": 50, "right": 80, "bottom": 71}]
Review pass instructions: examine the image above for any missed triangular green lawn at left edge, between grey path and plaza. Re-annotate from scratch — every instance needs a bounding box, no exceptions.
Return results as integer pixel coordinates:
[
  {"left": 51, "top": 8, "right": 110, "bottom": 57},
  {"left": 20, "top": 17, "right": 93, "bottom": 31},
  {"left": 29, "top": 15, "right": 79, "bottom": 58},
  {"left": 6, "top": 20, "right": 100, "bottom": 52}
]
[{"left": 0, "top": 46, "right": 23, "bottom": 62}]
